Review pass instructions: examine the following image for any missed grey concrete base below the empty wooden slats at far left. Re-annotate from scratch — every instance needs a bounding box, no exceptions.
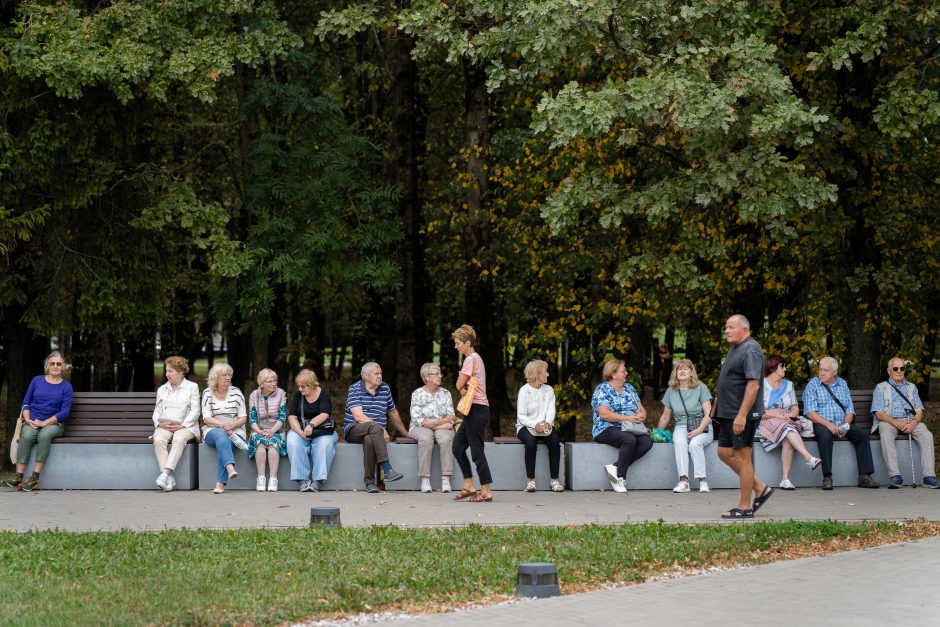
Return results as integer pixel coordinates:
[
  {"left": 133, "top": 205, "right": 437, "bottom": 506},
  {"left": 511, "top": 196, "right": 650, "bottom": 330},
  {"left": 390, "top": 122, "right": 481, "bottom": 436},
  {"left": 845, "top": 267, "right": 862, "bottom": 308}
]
[{"left": 26, "top": 442, "right": 197, "bottom": 490}]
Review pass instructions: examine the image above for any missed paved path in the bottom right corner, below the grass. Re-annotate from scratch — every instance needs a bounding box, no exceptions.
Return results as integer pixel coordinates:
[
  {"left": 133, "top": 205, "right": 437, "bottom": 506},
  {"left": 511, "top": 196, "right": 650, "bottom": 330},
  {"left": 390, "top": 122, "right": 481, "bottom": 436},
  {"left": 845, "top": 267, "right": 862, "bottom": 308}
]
[{"left": 394, "top": 538, "right": 940, "bottom": 627}]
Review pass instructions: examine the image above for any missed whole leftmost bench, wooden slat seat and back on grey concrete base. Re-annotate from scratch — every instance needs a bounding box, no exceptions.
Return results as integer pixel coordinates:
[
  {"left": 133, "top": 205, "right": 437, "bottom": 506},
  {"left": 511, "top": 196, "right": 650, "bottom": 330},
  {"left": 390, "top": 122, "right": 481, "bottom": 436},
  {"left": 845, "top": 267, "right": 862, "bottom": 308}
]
[{"left": 27, "top": 392, "right": 198, "bottom": 490}]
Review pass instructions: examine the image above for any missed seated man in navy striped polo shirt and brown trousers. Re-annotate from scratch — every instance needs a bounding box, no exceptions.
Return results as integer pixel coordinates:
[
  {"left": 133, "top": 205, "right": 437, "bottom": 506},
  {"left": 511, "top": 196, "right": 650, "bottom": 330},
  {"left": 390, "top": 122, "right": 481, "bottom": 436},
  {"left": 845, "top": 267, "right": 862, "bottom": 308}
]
[{"left": 343, "top": 361, "right": 408, "bottom": 494}]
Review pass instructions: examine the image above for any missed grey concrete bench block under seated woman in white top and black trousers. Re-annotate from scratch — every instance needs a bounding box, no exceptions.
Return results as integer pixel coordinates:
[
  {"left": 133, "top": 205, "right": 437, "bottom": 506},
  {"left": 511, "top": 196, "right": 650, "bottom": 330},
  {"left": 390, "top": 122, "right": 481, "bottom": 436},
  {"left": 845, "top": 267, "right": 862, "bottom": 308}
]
[{"left": 385, "top": 442, "right": 565, "bottom": 490}]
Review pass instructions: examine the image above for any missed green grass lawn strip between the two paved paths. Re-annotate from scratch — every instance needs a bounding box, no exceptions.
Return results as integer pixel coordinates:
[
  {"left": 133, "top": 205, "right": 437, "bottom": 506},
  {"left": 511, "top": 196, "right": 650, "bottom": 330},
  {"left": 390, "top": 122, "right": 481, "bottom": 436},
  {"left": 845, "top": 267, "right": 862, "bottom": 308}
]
[{"left": 0, "top": 521, "right": 938, "bottom": 625}]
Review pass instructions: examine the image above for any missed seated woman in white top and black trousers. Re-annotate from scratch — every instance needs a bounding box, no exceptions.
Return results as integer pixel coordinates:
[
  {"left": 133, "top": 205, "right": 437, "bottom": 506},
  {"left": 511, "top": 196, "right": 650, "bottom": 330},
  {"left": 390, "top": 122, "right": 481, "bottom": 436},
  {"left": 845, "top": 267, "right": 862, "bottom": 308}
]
[{"left": 516, "top": 359, "right": 565, "bottom": 492}]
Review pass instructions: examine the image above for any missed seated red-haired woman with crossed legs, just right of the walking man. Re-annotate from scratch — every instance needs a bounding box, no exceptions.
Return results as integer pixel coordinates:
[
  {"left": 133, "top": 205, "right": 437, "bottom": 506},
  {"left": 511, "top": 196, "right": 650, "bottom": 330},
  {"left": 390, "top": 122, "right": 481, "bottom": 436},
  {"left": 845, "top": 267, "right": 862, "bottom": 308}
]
[{"left": 757, "top": 355, "right": 822, "bottom": 490}]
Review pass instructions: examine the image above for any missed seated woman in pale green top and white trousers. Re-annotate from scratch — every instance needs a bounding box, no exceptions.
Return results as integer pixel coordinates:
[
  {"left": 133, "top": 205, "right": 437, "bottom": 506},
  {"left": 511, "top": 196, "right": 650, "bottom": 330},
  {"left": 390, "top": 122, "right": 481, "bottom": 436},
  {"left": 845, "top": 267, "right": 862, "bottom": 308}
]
[{"left": 659, "top": 359, "right": 714, "bottom": 492}]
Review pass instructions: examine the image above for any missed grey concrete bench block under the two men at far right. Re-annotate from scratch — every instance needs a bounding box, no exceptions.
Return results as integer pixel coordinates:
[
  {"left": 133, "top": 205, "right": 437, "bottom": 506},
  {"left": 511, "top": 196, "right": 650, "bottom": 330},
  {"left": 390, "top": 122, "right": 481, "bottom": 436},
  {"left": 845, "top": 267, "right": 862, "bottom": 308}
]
[{"left": 754, "top": 440, "right": 923, "bottom": 488}]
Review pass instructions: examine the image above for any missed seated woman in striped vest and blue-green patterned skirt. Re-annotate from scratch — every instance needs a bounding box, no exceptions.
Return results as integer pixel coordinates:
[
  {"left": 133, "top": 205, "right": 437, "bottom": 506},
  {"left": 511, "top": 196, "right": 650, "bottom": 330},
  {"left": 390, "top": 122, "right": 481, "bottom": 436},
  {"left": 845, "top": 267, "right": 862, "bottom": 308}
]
[{"left": 248, "top": 368, "right": 287, "bottom": 492}]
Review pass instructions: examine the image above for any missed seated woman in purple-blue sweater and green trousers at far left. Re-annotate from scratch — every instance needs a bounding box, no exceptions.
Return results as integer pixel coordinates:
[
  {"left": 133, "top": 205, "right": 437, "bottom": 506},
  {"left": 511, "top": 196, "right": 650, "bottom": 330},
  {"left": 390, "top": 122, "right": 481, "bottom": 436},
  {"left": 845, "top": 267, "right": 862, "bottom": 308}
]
[{"left": 7, "top": 351, "right": 72, "bottom": 492}]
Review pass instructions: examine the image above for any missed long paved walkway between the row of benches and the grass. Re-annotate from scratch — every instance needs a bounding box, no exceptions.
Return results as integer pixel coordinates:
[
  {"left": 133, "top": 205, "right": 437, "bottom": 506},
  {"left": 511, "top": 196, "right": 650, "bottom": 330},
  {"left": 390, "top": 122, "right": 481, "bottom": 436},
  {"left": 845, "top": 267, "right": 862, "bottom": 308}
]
[{"left": 0, "top": 488, "right": 940, "bottom": 531}]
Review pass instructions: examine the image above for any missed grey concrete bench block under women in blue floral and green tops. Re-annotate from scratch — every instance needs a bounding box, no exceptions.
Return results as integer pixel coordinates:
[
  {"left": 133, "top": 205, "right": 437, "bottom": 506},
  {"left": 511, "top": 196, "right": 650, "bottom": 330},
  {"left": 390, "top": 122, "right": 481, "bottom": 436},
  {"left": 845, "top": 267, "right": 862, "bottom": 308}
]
[{"left": 565, "top": 442, "right": 739, "bottom": 490}]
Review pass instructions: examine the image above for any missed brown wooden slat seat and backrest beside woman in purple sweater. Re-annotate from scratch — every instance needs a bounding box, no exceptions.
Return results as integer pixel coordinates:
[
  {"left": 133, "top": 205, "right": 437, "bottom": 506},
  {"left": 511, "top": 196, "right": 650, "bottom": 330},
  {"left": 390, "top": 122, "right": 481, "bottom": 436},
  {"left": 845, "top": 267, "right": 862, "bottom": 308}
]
[{"left": 56, "top": 392, "right": 157, "bottom": 444}]
